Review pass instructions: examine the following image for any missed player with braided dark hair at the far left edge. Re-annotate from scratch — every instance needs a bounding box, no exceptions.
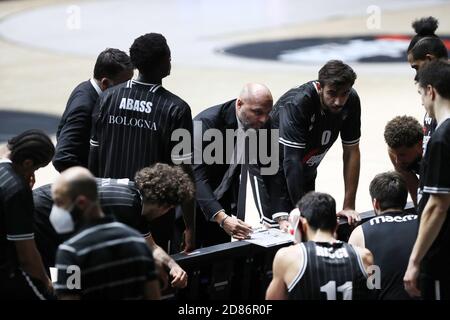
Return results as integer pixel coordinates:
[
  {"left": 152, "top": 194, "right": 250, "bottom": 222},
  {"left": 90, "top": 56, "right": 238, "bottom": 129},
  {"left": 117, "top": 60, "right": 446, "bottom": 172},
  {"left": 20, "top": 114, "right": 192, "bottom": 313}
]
[{"left": 0, "top": 130, "right": 55, "bottom": 299}]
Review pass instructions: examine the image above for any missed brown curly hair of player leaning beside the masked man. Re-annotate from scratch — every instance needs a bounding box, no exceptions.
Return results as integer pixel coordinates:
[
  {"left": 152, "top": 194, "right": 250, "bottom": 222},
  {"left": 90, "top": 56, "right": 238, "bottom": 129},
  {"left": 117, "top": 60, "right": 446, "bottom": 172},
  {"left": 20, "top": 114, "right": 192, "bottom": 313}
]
[{"left": 134, "top": 163, "right": 195, "bottom": 206}]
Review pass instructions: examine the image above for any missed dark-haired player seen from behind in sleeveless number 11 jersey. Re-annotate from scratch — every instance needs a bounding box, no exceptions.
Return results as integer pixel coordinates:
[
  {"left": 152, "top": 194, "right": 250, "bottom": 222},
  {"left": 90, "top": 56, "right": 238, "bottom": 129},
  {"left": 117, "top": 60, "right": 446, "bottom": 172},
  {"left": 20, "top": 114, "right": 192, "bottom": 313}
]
[{"left": 266, "top": 192, "right": 373, "bottom": 300}]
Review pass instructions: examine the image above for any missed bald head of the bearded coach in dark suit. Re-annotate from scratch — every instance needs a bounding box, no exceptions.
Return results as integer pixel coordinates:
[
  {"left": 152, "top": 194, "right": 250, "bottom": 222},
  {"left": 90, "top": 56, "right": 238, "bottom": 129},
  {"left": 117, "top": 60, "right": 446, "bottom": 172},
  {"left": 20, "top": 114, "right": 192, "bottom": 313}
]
[{"left": 236, "top": 83, "right": 273, "bottom": 129}]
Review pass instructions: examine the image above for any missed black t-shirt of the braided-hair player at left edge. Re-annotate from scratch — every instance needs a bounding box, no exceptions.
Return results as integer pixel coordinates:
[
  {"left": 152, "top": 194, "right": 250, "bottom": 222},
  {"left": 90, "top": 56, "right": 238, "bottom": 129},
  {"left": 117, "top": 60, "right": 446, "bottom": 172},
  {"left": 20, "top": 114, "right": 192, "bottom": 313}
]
[{"left": 0, "top": 160, "right": 34, "bottom": 272}]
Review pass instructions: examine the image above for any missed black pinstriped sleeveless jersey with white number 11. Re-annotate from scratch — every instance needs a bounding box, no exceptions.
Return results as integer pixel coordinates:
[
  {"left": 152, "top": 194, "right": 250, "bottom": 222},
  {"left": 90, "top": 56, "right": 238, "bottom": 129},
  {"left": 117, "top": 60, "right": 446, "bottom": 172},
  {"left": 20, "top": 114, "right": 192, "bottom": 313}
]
[{"left": 288, "top": 241, "right": 367, "bottom": 300}]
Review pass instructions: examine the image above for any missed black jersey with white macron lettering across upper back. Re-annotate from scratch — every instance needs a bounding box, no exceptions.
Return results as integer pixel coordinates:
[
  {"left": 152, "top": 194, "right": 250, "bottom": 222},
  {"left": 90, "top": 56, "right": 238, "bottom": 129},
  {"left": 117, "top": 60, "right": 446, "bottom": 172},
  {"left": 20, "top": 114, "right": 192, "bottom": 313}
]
[{"left": 361, "top": 211, "right": 419, "bottom": 300}]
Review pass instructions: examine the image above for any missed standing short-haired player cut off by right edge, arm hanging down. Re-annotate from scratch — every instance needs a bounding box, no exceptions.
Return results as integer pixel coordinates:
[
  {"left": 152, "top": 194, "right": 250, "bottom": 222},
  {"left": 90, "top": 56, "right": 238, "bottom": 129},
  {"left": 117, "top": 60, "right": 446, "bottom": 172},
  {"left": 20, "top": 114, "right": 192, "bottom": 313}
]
[{"left": 404, "top": 60, "right": 450, "bottom": 300}]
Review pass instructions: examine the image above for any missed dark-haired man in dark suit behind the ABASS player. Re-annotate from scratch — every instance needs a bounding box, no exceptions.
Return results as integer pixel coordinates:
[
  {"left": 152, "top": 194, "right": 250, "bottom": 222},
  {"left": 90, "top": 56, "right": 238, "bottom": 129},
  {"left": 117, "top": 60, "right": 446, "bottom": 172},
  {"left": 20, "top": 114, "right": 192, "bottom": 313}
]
[{"left": 53, "top": 48, "right": 134, "bottom": 172}]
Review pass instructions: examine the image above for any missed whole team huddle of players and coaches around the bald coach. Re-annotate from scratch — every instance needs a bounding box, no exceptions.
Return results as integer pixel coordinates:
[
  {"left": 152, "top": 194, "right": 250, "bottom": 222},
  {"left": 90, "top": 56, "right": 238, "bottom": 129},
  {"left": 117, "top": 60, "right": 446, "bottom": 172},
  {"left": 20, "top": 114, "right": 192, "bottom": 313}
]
[{"left": 0, "top": 17, "right": 450, "bottom": 300}]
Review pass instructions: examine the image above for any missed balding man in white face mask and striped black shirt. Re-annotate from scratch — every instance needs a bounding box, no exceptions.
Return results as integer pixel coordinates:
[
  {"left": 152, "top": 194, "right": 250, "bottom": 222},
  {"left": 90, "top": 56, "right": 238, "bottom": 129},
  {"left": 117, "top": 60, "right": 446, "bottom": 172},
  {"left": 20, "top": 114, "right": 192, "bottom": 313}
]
[{"left": 50, "top": 167, "right": 160, "bottom": 299}]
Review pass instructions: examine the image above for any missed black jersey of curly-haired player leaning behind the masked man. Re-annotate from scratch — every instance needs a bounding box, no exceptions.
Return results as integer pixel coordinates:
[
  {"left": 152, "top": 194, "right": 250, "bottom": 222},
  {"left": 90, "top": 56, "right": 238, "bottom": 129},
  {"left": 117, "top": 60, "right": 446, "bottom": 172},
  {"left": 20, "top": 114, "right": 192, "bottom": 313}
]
[{"left": 33, "top": 178, "right": 150, "bottom": 266}]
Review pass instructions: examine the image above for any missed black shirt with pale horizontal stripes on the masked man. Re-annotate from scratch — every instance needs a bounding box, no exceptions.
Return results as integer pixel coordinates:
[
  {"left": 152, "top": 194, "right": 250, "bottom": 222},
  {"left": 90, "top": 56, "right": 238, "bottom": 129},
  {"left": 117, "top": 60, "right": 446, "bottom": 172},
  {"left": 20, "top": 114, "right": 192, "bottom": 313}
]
[{"left": 54, "top": 217, "right": 156, "bottom": 300}]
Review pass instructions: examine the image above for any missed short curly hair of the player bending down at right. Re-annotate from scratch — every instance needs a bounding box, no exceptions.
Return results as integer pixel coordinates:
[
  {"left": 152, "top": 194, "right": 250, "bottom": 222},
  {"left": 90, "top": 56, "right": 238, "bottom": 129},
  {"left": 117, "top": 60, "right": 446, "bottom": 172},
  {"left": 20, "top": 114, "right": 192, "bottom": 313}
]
[{"left": 384, "top": 116, "right": 423, "bottom": 148}]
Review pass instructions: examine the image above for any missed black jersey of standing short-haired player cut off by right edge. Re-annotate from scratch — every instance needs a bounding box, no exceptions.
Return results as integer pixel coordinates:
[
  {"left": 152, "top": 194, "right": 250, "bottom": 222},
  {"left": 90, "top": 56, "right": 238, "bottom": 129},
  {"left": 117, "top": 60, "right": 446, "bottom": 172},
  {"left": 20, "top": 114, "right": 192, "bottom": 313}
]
[{"left": 418, "top": 119, "right": 450, "bottom": 280}]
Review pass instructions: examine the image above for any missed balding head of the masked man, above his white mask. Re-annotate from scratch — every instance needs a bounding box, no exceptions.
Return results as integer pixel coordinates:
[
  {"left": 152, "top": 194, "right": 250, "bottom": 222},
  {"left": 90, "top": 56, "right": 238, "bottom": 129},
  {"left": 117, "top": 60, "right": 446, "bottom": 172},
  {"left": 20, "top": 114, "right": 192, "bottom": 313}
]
[{"left": 52, "top": 167, "right": 98, "bottom": 208}]
